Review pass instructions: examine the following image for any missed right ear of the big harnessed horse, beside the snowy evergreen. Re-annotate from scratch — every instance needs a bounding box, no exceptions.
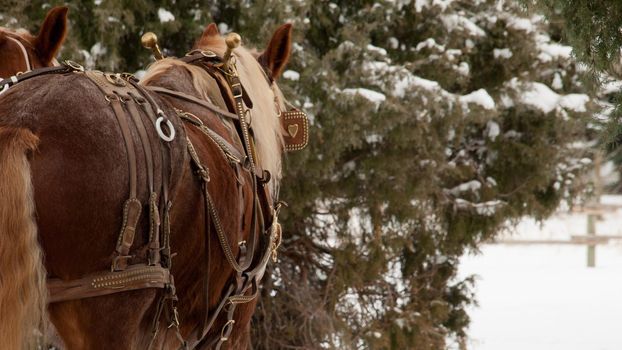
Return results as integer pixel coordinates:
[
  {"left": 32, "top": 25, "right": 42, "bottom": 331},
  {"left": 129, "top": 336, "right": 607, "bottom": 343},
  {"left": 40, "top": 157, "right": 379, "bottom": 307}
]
[{"left": 258, "top": 23, "right": 292, "bottom": 80}]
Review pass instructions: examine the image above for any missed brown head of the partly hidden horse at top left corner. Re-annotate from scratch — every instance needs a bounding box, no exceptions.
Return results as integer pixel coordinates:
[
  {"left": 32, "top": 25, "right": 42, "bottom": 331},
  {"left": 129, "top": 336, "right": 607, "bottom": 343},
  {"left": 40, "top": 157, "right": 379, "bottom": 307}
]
[{"left": 0, "top": 7, "right": 68, "bottom": 78}]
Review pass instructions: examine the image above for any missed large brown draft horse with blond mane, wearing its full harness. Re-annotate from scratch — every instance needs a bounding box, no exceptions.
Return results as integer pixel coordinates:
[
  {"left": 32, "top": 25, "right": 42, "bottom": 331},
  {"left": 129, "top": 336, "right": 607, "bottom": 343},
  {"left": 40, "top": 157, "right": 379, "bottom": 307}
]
[{"left": 0, "top": 19, "right": 307, "bottom": 349}]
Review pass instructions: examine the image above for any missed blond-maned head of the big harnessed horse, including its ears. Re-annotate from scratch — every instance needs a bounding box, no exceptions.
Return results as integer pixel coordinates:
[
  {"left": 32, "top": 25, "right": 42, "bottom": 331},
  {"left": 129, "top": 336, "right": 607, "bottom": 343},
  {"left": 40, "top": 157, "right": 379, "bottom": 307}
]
[{"left": 195, "top": 23, "right": 292, "bottom": 183}]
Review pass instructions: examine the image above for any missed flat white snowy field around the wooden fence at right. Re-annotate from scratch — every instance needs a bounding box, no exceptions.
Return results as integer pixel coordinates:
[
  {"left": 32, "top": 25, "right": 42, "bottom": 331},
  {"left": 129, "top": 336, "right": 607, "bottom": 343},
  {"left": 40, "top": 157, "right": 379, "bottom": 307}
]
[{"left": 461, "top": 201, "right": 622, "bottom": 350}]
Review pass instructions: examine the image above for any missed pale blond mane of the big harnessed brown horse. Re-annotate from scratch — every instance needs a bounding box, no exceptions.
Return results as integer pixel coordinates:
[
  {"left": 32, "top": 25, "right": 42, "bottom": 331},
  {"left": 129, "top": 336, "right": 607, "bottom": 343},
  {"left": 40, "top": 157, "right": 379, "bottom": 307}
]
[{"left": 141, "top": 37, "right": 286, "bottom": 191}]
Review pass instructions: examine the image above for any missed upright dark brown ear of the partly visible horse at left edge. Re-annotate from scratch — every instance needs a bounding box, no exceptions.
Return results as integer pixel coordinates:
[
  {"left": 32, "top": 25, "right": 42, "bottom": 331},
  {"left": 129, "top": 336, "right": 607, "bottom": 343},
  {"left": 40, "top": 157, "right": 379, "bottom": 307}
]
[{"left": 34, "top": 6, "right": 69, "bottom": 64}]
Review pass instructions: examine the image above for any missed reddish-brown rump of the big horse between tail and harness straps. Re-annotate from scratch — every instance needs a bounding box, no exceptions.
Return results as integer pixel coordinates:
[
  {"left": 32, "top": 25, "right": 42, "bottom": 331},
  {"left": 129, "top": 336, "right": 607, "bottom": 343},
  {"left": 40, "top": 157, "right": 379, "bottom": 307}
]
[{"left": 0, "top": 73, "right": 146, "bottom": 279}]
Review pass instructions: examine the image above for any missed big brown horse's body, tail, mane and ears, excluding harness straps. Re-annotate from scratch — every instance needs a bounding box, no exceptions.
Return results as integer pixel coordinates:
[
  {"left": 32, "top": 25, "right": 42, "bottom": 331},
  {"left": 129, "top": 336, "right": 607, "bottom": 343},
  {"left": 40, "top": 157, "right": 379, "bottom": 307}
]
[{"left": 0, "top": 19, "right": 291, "bottom": 349}]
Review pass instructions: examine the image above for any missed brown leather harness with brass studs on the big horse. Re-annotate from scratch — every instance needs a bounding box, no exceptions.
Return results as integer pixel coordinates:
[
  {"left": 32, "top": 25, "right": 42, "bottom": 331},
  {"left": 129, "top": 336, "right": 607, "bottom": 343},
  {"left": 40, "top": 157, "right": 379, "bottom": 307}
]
[{"left": 0, "top": 51, "right": 308, "bottom": 349}]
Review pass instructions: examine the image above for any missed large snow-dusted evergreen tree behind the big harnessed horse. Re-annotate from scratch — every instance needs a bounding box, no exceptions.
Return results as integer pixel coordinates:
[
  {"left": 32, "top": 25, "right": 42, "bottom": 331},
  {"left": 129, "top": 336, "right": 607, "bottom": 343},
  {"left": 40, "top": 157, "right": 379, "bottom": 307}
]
[{"left": 3, "top": 0, "right": 600, "bottom": 350}]
